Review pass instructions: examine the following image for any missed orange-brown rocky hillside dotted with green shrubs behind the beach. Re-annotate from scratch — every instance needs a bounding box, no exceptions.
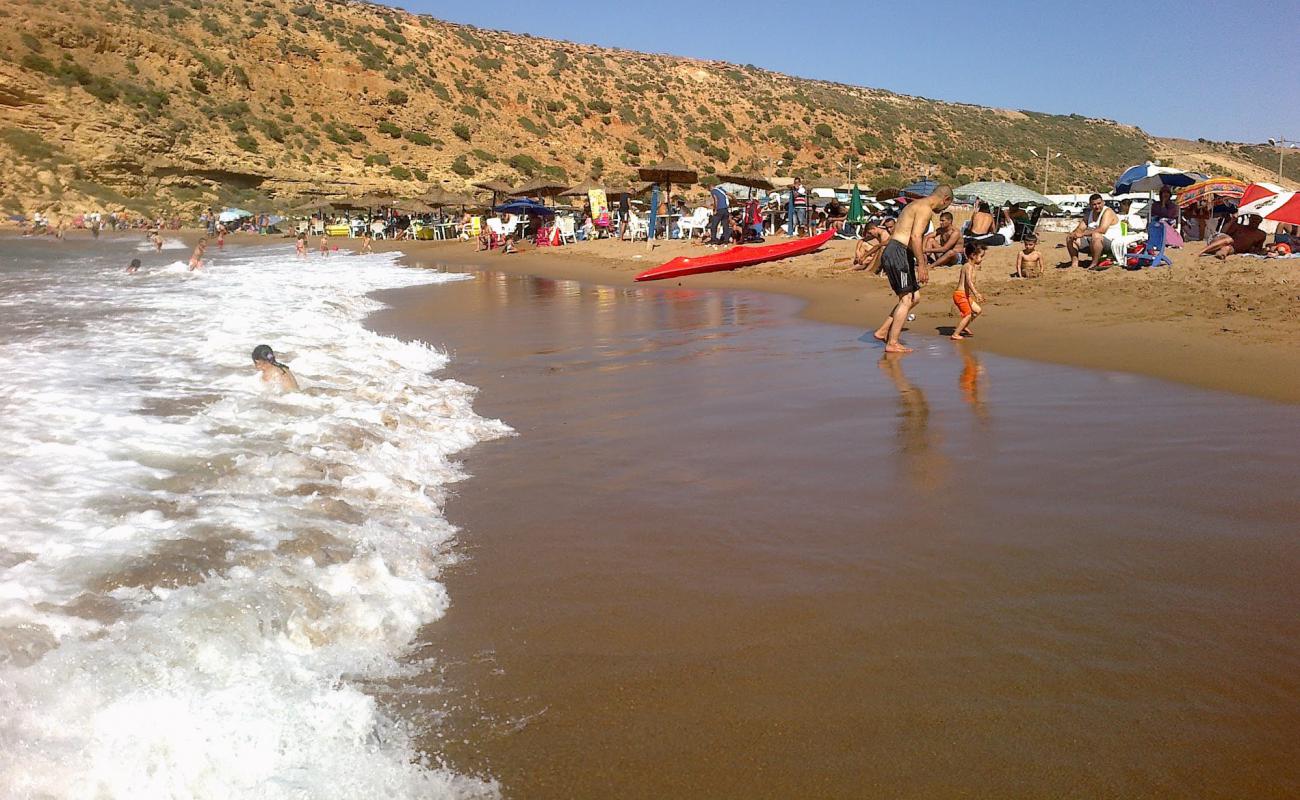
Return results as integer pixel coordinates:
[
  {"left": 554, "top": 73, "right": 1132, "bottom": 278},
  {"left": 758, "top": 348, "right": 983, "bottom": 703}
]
[{"left": 0, "top": 0, "right": 1190, "bottom": 215}]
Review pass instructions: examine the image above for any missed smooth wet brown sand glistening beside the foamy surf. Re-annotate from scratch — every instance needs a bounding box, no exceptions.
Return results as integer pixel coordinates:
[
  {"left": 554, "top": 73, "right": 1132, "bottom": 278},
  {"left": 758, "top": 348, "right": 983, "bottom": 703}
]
[{"left": 371, "top": 264, "right": 1300, "bottom": 797}]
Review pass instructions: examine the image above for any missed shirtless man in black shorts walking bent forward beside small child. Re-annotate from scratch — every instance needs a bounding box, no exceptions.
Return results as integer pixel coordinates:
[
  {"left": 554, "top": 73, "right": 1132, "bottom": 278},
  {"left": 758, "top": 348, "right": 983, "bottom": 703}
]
[{"left": 875, "top": 183, "right": 953, "bottom": 353}]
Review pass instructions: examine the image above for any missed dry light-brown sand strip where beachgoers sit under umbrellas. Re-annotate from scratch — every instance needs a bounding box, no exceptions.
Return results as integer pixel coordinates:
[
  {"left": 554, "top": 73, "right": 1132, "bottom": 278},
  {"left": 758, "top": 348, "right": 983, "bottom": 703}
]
[{"left": 364, "top": 233, "right": 1300, "bottom": 403}]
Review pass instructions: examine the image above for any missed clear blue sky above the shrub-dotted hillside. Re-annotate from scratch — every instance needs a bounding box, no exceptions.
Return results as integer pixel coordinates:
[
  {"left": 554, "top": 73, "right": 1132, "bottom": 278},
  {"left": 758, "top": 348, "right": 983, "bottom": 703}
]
[{"left": 387, "top": 0, "right": 1300, "bottom": 142}]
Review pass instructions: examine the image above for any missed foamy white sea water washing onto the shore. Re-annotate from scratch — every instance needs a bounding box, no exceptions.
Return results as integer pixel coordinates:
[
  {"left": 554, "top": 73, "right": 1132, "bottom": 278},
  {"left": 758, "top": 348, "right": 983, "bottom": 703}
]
[{"left": 0, "top": 239, "right": 510, "bottom": 799}]
